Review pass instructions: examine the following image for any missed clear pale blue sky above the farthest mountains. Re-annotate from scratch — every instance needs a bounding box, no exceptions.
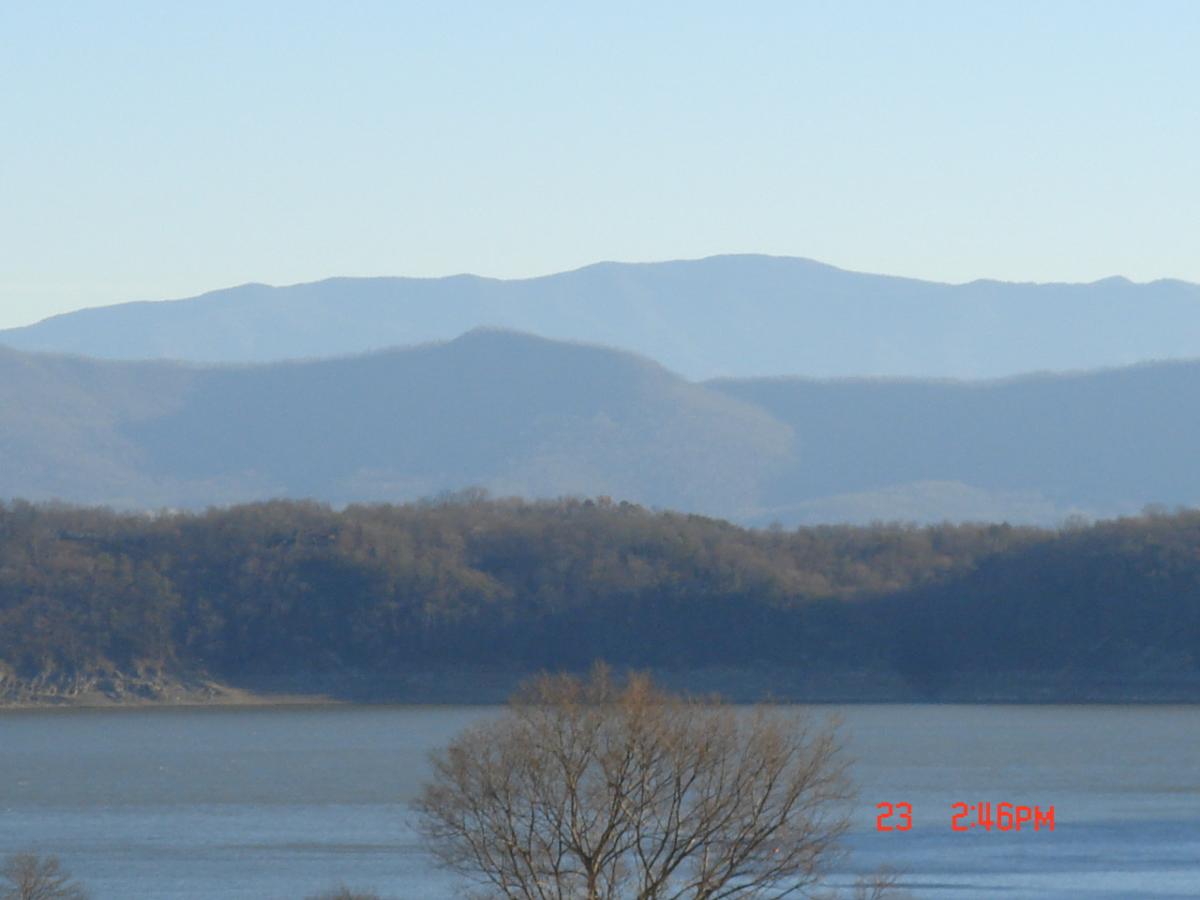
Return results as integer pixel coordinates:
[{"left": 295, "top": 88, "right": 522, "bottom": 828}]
[{"left": 0, "top": 0, "right": 1200, "bottom": 326}]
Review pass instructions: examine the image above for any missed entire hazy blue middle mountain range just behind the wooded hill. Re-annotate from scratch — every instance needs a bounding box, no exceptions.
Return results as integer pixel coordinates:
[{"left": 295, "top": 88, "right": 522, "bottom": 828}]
[{"left": 0, "top": 330, "right": 1200, "bottom": 526}]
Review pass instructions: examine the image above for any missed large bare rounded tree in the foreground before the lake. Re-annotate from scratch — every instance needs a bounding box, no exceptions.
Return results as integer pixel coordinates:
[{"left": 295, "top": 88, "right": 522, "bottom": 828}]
[{"left": 418, "top": 668, "right": 877, "bottom": 900}]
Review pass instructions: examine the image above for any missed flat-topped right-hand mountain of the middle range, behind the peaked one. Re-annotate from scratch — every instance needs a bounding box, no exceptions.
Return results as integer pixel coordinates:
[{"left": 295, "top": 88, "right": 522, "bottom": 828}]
[{"left": 709, "top": 362, "right": 1200, "bottom": 522}]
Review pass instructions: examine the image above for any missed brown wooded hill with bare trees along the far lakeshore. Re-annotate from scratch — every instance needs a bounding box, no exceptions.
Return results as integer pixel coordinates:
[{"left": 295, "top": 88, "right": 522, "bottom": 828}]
[{"left": 0, "top": 494, "right": 1200, "bottom": 700}]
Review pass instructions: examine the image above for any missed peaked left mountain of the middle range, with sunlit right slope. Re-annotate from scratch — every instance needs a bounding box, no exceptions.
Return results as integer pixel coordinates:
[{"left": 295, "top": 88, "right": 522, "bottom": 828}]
[{"left": 0, "top": 331, "right": 792, "bottom": 516}]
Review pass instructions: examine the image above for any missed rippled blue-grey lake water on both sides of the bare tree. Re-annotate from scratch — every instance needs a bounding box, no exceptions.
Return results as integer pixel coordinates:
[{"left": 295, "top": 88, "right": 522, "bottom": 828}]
[{"left": 0, "top": 706, "right": 1200, "bottom": 900}]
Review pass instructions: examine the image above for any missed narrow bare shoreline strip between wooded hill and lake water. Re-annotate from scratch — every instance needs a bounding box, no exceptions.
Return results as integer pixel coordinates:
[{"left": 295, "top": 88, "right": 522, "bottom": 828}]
[{"left": 0, "top": 666, "right": 1200, "bottom": 712}]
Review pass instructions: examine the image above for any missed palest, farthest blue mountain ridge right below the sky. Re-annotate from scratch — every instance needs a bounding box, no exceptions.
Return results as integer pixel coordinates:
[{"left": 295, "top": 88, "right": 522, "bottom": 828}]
[{"left": 0, "top": 256, "right": 1200, "bottom": 379}]
